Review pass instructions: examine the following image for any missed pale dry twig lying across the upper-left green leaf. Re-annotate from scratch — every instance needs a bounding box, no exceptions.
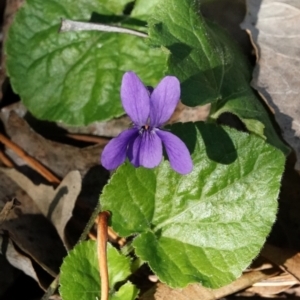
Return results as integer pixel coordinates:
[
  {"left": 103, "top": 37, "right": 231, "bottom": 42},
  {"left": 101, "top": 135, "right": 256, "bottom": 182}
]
[{"left": 60, "top": 19, "right": 148, "bottom": 38}]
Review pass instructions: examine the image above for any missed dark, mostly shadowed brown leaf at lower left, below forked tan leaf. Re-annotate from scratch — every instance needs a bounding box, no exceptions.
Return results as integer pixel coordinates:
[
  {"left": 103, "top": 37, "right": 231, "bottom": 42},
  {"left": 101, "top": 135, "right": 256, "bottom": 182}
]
[{"left": 1, "top": 190, "right": 67, "bottom": 276}]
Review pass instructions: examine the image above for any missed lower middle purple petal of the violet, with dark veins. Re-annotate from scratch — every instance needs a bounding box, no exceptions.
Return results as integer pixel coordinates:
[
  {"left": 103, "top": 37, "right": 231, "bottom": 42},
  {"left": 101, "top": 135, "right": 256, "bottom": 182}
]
[{"left": 131, "top": 131, "right": 162, "bottom": 168}]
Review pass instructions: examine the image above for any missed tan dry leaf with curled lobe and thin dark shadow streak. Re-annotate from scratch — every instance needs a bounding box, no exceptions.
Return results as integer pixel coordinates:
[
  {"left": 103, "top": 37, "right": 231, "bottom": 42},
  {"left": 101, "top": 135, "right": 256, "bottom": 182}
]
[{"left": 0, "top": 168, "right": 81, "bottom": 249}]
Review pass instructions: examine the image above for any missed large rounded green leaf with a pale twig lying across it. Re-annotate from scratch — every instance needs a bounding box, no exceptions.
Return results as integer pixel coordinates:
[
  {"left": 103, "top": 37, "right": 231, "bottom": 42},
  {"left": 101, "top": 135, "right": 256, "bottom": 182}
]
[{"left": 6, "top": 0, "right": 166, "bottom": 125}]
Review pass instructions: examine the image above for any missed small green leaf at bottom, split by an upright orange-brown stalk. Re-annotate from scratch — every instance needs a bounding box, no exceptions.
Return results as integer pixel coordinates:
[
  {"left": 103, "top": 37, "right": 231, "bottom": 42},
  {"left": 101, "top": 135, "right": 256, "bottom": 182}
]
[{"left": 59, "top": 241, "right": 138, "bottom": 300}]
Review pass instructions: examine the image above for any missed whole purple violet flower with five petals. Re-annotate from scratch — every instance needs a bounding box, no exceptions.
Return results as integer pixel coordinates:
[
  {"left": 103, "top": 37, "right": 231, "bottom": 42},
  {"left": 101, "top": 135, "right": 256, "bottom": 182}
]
[{"left": 101, "top": 72, "right": 193, "bottom": 174}]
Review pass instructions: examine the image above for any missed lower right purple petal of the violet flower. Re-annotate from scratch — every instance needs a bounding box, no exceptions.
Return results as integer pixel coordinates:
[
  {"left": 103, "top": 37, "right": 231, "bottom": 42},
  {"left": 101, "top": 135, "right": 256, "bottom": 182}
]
[{"left": 156, "top": 130, "right": 193, "bottom": 175}]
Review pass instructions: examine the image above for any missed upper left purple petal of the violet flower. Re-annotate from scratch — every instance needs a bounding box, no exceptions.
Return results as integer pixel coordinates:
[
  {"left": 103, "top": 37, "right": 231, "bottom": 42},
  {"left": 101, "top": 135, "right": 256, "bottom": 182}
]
[{"left": 121, "top": 72, "right": 150, "bottom": 126}]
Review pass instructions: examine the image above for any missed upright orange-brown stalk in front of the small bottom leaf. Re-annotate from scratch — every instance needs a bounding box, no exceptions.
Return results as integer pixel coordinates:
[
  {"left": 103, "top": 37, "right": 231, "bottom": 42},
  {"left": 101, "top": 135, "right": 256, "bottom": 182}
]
[{"left": 97, "top": 211, "right": 110, "bottom": 300}]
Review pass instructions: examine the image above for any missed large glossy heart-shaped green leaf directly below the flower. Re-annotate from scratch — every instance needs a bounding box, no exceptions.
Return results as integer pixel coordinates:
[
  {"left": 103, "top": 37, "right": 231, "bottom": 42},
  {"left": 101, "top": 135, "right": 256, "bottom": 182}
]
[{"left": 100, "top": 123, "right": 284, "bottom": 288}]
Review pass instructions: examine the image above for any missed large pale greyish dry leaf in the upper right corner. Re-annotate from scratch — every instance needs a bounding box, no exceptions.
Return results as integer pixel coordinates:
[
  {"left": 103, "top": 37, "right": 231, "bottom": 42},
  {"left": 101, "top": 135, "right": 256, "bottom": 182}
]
[{"left": 242, "top": 0, "right": 300, "bottom": 170}]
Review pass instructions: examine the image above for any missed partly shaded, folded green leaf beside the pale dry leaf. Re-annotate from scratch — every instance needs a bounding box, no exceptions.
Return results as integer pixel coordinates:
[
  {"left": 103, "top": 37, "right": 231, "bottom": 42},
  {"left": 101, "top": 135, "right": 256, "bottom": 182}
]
[{"left": 149, "top": 0, "right": 289, "bottom": 153}]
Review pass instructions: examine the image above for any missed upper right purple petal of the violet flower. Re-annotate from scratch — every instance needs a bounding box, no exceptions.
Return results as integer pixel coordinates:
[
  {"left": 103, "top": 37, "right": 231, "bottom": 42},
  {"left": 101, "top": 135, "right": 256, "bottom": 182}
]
[{"left": 150, "top": 76, "right": 180, "bottom": 127}]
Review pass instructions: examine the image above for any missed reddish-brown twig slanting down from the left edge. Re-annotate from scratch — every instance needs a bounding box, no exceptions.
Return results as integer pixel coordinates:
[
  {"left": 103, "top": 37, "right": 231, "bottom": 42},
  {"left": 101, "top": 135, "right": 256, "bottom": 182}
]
[{"left": 0, "top": 133, "right": 60, "bottom": 184}]
